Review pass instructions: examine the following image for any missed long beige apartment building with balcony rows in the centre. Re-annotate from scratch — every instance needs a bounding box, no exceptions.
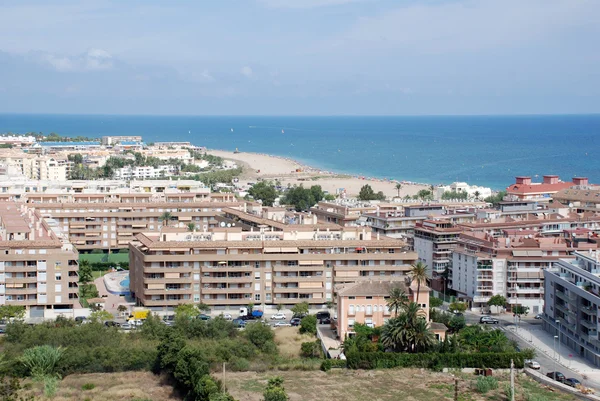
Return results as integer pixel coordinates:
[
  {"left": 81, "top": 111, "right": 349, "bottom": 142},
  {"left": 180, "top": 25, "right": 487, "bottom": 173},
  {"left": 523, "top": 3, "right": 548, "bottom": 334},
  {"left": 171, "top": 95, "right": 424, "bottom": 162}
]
[{"left": 129, "top": 225, "right": 417, "bottom": 311}]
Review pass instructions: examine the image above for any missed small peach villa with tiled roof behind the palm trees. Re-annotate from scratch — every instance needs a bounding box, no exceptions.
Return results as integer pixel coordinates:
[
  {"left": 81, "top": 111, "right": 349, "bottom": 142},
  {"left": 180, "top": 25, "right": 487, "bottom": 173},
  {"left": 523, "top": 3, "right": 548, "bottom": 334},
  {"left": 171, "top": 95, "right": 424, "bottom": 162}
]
[{"left": 335, "top": 279, "right": 434, "bottom": 340}]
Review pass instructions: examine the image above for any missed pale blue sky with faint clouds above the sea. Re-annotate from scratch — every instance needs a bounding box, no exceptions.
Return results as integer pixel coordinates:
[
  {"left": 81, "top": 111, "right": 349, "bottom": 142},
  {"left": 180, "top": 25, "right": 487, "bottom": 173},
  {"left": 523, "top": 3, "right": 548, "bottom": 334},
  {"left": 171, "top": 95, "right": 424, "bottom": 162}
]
[{"left": 0, "top": 0, "right": 600, "bottom": 115}]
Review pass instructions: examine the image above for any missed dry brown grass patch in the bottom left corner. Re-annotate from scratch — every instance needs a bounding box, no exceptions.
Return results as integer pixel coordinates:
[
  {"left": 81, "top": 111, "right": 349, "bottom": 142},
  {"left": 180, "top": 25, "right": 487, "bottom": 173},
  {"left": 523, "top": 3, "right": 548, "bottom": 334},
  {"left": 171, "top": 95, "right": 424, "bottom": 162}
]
[{"left": 25, "top": 372, "right": 181, "bottom": 401}]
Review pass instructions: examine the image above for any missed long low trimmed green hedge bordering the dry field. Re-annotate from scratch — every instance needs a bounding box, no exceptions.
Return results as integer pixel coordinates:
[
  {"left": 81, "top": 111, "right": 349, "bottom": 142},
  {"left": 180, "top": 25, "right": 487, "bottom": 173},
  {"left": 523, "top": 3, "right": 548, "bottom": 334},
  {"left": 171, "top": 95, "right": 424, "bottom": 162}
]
[{"left": 346, "top": 352, "right": 524, "bottom": 369}]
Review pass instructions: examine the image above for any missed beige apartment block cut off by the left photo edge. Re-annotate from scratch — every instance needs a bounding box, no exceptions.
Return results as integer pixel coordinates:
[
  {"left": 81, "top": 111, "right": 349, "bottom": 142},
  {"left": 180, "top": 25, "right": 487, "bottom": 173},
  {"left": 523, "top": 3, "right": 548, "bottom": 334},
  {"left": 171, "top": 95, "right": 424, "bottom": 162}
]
[{"left": 0, "top": 203, "right": 80, "bottom": 318}]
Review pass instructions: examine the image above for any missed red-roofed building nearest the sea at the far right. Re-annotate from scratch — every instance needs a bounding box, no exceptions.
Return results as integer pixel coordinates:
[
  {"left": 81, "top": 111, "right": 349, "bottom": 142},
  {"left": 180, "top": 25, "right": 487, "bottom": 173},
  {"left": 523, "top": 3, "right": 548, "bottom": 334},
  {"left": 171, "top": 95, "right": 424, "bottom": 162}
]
[{"left": 506, "top": 175, "right": 588, "bottom": 202}]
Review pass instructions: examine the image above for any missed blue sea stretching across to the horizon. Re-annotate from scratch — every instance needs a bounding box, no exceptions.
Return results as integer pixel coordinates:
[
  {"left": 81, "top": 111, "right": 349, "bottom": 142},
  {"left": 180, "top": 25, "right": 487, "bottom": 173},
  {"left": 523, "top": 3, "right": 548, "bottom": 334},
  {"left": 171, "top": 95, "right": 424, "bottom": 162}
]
[{"left": 0, "top": 114, "right": 600, "bottom": 189}]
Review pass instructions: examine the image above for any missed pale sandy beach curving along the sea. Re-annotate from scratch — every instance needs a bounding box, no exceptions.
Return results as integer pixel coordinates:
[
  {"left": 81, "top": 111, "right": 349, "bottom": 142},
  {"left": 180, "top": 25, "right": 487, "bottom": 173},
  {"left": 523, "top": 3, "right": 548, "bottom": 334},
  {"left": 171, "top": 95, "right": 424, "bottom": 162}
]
[{"left": 208, "top": 150, "right": 429, "bottom": 199}]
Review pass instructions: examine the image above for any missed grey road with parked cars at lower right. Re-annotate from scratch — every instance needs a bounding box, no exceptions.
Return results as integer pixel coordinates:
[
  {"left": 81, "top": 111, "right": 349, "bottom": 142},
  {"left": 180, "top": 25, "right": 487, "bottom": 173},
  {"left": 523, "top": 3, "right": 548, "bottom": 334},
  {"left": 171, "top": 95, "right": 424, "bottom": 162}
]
[{"left": 465, "top": 312, "right": 600, "bottom": 392}]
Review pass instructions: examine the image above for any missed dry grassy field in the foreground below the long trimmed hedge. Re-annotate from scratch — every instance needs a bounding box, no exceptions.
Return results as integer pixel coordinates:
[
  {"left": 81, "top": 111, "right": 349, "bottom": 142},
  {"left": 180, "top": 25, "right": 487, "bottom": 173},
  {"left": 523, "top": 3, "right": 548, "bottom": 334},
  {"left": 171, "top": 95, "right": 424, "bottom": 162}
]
[{"left": 226, "top": 369, "right": 577, "bottom": 401}]
